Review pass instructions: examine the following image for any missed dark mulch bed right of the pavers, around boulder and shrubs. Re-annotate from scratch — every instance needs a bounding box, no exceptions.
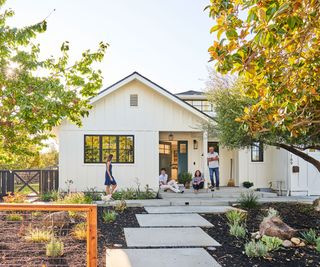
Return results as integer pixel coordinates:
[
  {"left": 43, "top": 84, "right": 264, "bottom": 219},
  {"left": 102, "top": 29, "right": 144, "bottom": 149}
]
[{"left": 203, "top": 203, "right": 320, "bottom": 267}]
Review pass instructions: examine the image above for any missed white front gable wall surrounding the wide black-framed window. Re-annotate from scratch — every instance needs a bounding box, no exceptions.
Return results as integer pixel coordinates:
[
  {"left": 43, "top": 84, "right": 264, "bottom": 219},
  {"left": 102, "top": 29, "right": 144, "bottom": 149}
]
[{"left": 58, "top": 80, "right": 205, "bottom": 191}]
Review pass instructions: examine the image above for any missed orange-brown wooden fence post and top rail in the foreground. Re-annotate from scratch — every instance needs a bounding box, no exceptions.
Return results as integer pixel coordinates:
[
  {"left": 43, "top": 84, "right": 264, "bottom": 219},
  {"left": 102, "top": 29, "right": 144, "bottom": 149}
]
[{"left": 0, "top": 203, "right": 98, "bottom": 267}]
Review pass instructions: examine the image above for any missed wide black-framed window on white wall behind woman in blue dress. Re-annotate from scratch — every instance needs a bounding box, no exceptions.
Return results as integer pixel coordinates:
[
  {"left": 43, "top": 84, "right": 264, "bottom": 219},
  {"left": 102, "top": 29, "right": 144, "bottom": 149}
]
[{"left": 84, "top": 135, "right": 134, "bottom": 163}]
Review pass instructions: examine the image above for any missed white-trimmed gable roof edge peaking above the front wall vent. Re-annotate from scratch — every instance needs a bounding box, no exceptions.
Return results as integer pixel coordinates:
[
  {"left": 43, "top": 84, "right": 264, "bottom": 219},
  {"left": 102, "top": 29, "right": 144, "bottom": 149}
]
[{"left": 90, "top": 71, "right": 212, "bottom": 120}]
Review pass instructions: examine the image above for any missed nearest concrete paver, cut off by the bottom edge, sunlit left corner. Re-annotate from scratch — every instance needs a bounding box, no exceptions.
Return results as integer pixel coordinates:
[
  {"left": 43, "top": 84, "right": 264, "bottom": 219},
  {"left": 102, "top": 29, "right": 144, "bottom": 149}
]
[{"left": 106, "top": 248, "right": 221, "bottom": 267}]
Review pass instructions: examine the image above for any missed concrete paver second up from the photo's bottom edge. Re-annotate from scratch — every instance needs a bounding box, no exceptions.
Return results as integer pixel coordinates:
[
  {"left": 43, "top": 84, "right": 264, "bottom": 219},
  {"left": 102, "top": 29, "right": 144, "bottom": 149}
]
[{"left": 124, "top": 227, "right": 220, "bottom": 247}]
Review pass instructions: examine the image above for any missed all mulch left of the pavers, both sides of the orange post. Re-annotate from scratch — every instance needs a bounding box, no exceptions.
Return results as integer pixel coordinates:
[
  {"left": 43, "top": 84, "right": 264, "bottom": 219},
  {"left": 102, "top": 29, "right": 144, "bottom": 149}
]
[{"left": 0, "top": 207, "right": 146, "bottom": 267}]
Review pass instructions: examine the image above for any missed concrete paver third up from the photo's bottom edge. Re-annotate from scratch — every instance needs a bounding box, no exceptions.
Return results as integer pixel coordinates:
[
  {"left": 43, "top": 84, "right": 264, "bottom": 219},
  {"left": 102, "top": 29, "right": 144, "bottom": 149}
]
[{"left": 136, "top": 213, "right": 213, "bottom": 227}]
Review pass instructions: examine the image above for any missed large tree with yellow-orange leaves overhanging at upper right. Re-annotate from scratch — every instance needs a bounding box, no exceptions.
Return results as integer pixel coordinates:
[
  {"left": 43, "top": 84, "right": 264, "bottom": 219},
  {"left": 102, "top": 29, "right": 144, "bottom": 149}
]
[{"left": 208, "top": 0, "right": 320, "bottom": 171}]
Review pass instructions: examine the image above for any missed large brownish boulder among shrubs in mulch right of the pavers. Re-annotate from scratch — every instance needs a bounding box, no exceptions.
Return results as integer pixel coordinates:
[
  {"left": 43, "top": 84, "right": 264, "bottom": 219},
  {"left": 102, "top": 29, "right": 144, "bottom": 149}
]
[{"left": 259, "top": 216, "right": 296, "bottom": 239}]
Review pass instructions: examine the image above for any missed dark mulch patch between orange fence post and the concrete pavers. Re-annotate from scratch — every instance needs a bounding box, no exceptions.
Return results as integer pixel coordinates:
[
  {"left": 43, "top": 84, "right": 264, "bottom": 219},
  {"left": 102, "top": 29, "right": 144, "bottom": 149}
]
[{"left": 98, "top": 207, "right": 146, "bottom": 266}]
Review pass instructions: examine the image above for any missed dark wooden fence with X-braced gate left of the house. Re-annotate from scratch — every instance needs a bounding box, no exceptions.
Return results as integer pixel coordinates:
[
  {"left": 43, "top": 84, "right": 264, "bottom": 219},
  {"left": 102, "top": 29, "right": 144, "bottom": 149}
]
[{"left": 0, "top": 170, "right": 59, "bottom": 196}]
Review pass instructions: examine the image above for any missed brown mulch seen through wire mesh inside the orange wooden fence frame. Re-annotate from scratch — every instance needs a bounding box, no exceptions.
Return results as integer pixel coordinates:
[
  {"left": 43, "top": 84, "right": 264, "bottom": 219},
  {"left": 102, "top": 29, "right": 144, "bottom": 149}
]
[{"left": 0, "top": 213, "right": 86, "bottom": 267}]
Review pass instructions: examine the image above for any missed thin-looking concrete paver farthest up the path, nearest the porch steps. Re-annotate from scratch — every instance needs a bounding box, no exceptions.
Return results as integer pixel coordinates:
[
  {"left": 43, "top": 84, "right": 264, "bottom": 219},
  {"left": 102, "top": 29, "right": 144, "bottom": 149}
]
[{"left": 145, "top": 206, "right": 235, "bottom": 213}]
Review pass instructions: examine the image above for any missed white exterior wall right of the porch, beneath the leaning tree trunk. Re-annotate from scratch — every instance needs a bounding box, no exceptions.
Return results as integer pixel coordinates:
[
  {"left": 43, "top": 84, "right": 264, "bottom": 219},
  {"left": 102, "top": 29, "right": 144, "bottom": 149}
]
[{"left": 236, "top": 147, "right": 320, "bottom": 196}]
